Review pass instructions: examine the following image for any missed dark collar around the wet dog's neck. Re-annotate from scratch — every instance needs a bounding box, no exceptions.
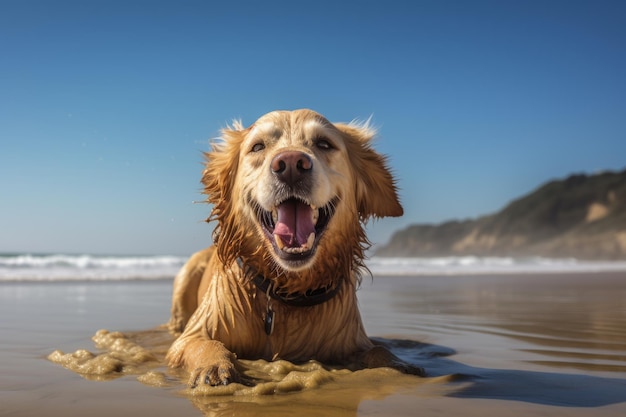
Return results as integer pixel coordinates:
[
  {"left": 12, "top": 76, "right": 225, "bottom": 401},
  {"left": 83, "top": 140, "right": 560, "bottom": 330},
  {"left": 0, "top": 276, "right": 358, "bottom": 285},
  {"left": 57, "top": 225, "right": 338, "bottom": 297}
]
[{"left": 237, "top": 258, "right": 343, "bottom": 307}]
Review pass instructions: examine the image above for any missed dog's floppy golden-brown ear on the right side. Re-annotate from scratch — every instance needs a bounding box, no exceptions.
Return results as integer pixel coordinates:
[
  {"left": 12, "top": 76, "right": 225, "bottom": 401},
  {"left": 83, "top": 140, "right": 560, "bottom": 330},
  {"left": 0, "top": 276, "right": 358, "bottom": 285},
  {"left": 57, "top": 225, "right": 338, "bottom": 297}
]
[{"left": 335, "top": 124, "right": 403, "bottom": 220}]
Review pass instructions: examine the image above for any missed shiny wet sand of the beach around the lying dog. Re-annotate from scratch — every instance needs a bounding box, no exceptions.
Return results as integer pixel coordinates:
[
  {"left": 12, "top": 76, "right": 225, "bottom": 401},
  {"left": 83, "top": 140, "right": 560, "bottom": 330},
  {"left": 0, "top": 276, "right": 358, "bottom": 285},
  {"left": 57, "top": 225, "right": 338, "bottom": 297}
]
[{"left": 0, "top": 273, "right": 626, "bottom": 416}]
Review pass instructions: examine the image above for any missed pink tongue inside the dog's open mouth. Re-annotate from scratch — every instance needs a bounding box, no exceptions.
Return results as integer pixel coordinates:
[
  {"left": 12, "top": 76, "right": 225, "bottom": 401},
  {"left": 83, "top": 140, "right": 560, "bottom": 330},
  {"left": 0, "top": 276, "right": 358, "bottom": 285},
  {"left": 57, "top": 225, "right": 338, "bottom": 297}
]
[{"left": 274, "top": 199, "right": 315, "bottom": 248}]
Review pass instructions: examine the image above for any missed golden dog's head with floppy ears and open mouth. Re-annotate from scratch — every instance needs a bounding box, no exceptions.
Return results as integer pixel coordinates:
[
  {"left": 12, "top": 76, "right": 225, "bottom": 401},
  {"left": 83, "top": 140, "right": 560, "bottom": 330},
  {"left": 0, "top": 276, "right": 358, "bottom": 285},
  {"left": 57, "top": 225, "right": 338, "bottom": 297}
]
[{"left": 203, "top": 110, "right": 402, "bottom": 282}]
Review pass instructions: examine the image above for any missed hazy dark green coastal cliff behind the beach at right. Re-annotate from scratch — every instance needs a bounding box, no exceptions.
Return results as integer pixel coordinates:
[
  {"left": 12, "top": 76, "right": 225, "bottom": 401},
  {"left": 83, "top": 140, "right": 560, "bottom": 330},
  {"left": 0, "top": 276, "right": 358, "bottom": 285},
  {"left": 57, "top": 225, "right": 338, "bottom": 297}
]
[{"left": 376, "top": 170, "right": 626, "bottom": 260}]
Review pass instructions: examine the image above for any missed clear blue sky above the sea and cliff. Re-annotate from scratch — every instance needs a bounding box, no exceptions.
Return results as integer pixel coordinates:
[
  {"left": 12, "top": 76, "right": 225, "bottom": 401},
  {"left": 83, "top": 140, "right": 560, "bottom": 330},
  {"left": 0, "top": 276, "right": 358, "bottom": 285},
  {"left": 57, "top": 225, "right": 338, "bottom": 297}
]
[{"left": 0, "top": 0, "right": 626, "bottom": 255}]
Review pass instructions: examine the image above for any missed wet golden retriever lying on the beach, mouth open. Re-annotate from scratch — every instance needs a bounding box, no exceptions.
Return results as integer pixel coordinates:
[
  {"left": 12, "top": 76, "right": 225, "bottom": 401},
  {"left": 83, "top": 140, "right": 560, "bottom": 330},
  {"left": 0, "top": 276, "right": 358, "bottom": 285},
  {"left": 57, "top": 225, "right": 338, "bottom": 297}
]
[{"left": 167, "top": 109, "right": 423, "bottom": 386}]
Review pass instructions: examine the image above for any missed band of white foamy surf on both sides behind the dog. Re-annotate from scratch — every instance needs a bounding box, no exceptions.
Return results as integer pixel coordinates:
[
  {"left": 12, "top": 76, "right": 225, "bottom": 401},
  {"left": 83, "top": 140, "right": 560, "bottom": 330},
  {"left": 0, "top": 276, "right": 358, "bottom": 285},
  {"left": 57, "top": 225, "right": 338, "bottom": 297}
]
[{"left": 0, "top": 253, "right": 626, "bottom": 282}]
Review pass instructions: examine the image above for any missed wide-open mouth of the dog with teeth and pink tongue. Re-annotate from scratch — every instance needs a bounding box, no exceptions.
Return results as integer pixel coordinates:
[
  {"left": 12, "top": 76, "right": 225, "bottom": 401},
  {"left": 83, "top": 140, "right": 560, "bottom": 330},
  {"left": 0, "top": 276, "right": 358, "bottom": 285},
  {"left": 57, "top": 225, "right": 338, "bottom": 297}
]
[{"left": 260, "top": 197, "right": 337, "bottom": 261}]
